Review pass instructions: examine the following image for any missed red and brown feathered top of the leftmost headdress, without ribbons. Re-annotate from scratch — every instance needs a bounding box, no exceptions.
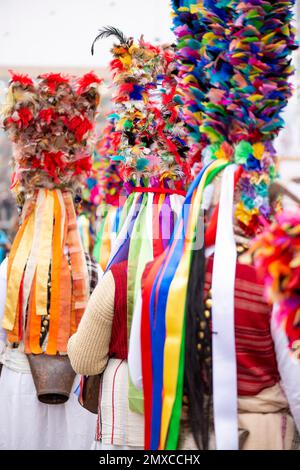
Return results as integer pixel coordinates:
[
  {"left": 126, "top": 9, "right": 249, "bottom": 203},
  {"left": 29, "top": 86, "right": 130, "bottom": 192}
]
[{"left": 3, "top": 73, "right": 101, "bottom": 195}]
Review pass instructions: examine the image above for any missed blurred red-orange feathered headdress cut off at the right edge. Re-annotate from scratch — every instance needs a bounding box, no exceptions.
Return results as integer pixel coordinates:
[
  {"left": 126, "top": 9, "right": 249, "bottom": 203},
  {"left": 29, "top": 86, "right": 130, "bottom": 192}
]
[{"left": 251, "top": 212, "right": 300, "bottom": 357}]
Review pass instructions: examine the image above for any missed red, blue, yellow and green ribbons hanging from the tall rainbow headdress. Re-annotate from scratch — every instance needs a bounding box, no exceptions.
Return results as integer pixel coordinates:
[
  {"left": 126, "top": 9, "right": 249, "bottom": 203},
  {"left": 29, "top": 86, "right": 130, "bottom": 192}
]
[{"left": 142, "top": 159, "right": 229, "bottom": 449}]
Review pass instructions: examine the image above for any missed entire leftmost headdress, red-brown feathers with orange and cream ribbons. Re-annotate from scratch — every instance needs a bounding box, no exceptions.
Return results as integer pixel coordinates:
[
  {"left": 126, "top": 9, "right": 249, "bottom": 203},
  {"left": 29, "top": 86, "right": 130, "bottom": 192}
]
[{"left": 3, "top": 73, "right": 101, "bottom": 355}]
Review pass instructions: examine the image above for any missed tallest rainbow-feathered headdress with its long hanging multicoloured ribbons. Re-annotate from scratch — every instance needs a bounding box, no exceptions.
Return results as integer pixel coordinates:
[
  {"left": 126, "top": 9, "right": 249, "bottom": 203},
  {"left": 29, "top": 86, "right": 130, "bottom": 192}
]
[{"left": 141, "top": 0, "right": 295, "bottom": 449}]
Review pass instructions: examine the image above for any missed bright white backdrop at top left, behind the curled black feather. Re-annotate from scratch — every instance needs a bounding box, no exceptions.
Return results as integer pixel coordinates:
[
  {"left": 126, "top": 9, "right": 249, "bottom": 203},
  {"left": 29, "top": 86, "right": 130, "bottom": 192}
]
[{"left": 0, "top": 0, "right": 174, "bottom": 68}]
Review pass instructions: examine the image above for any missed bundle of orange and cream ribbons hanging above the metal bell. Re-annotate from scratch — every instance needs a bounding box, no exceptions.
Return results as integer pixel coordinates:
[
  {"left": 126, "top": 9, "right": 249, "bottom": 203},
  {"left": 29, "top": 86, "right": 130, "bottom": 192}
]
[{"left": 3, "top": 189, "right": 89, "bottom": 355}]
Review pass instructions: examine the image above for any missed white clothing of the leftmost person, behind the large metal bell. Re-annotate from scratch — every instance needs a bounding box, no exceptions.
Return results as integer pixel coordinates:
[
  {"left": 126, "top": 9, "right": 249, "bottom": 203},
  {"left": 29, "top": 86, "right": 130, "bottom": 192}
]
[{"left": 0, "top": 258, "right": 97, "bottom": 450}]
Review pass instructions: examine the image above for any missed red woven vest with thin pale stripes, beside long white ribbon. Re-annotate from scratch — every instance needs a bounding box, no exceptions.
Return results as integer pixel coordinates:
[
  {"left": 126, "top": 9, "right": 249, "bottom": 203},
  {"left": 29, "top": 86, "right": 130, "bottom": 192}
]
[{"left": 205, "top": 257, "right": 280, "bottom": 396}]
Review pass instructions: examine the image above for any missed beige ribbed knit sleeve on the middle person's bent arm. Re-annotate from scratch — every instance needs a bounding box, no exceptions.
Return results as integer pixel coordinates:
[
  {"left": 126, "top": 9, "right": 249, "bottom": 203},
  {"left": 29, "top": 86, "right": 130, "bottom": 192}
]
[{"left": 68, "top": 271, "right": 115, "bottom": 375}]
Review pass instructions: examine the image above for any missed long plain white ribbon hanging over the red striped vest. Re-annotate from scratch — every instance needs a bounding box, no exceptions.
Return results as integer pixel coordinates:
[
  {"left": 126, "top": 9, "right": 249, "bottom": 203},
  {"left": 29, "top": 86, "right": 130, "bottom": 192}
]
[{"left": 212, "top": 165, "right": 239, "bottom": 450}]
